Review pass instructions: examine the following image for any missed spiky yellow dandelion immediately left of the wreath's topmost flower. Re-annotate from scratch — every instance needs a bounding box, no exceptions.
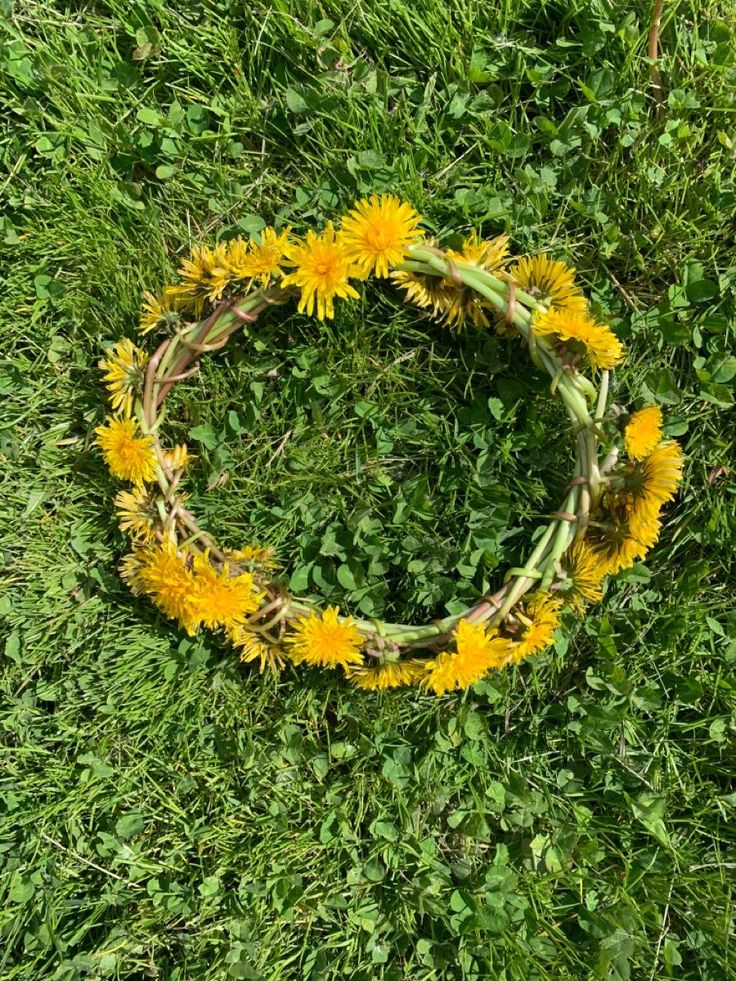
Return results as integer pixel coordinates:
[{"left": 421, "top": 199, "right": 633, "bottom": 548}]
[{"left": 281, "top": 221, "right": 358, "bottom": 320}]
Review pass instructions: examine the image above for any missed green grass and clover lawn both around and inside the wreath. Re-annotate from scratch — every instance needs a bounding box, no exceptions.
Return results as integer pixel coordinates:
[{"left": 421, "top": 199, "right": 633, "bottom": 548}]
[{"left": 0, "top": 0, "right": 736, "bottom": 981}]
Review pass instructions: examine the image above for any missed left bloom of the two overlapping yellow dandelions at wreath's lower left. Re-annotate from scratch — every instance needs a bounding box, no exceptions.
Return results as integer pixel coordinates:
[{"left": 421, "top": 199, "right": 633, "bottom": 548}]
[{"left": 124, "top": 540, "right": 202, "bottom": 636}]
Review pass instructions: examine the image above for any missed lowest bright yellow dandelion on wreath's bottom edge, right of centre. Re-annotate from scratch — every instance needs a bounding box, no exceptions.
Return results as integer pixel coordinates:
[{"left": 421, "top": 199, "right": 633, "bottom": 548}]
[{"left": 422, "top": 620, "right": 510, "bottom": 695}]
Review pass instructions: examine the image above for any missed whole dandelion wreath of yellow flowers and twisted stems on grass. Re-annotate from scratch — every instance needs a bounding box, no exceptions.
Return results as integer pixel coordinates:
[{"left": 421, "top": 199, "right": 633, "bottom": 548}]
[{"left": 96, "top": 195, "right": 683, "bottom": 695}]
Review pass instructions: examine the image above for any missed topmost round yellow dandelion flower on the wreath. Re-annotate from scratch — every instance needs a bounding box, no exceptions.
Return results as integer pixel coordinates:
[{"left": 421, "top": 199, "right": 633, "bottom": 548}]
[{"left": 341, "top": 194, "right": 422, "bottom": 279}]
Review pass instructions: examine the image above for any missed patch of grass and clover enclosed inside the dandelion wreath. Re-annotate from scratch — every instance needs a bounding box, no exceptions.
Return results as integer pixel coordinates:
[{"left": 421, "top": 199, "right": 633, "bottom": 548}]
[{"left": 165, "top": 287, "right": 570, "bottom": 622}]
